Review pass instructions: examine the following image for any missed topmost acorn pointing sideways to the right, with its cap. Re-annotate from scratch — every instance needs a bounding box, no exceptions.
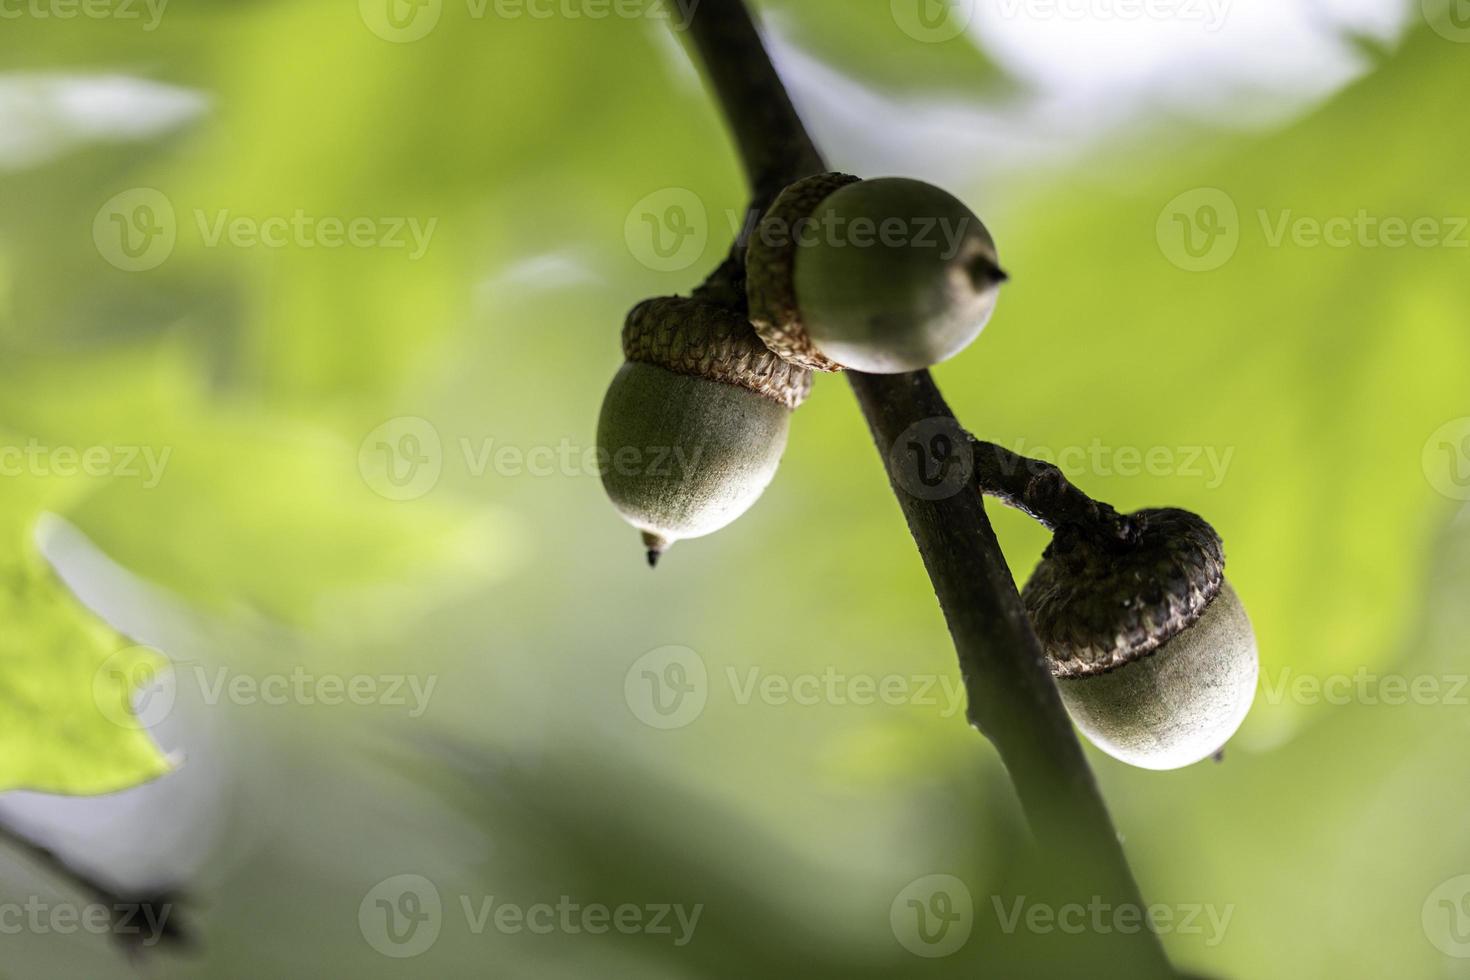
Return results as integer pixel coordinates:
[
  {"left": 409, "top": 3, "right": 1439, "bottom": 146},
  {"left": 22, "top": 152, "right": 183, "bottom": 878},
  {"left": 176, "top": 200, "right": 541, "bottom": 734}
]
[{"left": 745, "top": 173, "right": 1005, "bottom": 375}]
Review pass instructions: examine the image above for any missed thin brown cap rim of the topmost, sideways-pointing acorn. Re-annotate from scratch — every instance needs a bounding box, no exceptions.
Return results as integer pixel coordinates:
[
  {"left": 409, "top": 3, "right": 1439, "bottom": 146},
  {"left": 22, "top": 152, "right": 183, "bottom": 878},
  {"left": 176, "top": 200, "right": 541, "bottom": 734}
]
[{"left": 745, "top": 173, "right": 860, "bottom": 372}]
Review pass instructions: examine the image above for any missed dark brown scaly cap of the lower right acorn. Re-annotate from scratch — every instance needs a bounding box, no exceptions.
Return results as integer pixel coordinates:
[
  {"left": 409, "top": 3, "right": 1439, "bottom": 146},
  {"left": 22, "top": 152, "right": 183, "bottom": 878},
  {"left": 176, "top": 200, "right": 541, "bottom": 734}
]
[{"left": 1022, "top": 508, "right": 1225, "bottom": 677}]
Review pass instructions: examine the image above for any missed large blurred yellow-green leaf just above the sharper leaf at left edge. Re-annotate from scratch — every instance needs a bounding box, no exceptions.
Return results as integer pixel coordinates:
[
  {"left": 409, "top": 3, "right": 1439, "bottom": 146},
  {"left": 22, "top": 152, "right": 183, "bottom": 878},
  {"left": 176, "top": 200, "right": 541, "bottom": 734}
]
[{"left": 0, "top": 344, "right": 517, "bottom": 635}]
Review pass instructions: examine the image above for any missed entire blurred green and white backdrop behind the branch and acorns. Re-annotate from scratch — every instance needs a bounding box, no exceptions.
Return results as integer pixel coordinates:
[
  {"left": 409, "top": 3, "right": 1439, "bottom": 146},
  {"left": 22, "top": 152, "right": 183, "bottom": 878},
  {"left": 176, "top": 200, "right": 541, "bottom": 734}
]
[{"left": 0, "top": 0, "right": 1470, "bottom": 980}]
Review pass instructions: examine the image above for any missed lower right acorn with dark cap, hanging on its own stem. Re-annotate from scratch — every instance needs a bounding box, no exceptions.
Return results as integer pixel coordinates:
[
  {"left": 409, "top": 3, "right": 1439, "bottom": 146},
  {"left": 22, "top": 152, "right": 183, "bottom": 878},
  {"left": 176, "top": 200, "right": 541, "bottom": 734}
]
[{"left": 1022, "top": 508, "right": 1258, "bottom": 770}]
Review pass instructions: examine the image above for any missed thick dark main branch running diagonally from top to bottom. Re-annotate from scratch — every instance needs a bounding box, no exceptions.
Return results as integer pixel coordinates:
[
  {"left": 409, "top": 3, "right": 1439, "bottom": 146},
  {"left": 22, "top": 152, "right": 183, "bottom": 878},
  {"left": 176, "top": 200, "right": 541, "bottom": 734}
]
[{"left": 689, "top": 0, "right": 1176, "bottom": 977}]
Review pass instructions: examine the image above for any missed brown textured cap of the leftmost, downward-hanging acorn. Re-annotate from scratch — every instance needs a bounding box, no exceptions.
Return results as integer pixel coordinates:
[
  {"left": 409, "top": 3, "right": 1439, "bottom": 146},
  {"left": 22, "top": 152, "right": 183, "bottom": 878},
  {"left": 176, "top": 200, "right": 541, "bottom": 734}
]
[{"left": 623, "top": 297, "right": 811, "bottom": 408}]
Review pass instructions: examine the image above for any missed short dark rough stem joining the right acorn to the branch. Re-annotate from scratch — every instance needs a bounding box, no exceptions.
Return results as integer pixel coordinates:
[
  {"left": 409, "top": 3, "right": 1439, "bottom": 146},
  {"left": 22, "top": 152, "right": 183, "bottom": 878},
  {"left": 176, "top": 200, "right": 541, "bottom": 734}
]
[{"left": 970, "top": 435, "right": 1133, "bottom": 542}]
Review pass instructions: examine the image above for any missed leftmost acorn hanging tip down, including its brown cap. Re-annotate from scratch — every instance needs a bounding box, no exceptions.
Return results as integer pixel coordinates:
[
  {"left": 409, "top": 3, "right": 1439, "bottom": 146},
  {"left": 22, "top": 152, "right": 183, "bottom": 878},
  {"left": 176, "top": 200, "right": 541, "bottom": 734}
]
[{"left": 597, "top": 297, "right": 811, "bottom": 564}]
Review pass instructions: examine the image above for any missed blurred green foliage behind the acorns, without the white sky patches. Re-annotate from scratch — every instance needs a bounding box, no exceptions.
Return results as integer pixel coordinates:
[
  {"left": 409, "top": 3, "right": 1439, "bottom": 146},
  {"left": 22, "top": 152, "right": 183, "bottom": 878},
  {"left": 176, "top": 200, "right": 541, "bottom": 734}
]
[{"left": 0, "top": 0, "right": 1470, "bottom": 977}]
